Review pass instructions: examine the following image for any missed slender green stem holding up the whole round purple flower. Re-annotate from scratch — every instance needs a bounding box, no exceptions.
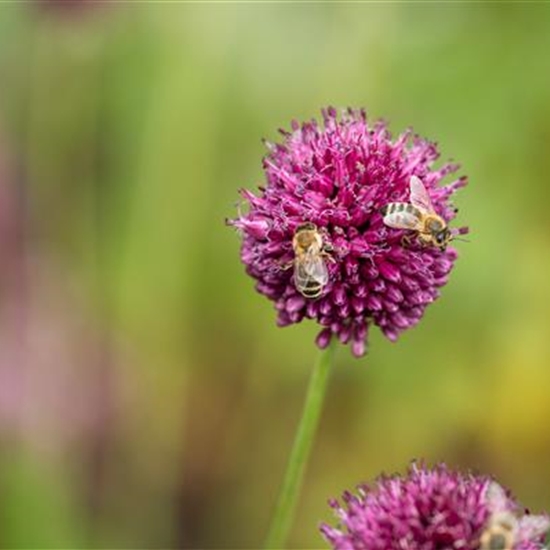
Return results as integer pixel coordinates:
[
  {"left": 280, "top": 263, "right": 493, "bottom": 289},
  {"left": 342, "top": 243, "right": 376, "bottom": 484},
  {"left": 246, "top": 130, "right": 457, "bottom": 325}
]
[{"left": 264, "top": 341, "right": 336, "bottom": 550}]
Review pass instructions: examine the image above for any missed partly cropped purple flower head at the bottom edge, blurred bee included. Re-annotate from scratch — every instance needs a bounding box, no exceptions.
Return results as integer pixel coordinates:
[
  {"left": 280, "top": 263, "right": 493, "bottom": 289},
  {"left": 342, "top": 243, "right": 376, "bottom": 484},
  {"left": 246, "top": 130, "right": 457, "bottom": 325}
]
[{"left": 321, "top": 464, "right": 550, "bottom": 550}]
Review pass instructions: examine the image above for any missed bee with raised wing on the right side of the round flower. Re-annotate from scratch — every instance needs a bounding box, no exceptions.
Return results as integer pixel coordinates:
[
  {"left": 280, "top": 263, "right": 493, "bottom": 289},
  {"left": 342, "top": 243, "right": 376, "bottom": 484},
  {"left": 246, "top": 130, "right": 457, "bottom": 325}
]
[{"left": 382, "top": 176, "right": 453, "bottom": 250}]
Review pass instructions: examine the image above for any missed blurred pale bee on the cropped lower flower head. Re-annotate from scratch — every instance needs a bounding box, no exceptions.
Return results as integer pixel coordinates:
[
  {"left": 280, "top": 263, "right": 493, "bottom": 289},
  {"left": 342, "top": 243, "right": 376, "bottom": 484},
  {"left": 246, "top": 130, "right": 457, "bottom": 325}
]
[{"left": 479, "top": 482, "right": 550, "bottom": 550}]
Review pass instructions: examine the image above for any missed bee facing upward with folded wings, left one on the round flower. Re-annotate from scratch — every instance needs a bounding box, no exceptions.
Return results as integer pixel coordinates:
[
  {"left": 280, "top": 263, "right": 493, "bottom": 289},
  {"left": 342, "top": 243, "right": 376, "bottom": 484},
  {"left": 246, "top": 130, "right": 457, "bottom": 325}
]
[{"left": 292, "top": 222, "right": 328, "bottom": 298}]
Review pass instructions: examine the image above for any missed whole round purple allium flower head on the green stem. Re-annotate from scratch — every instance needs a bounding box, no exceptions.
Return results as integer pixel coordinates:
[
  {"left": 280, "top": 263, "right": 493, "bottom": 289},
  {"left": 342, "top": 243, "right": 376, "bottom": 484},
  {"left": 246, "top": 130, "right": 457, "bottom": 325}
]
[{"left": 229, "top": 108, "right": 466, "bottom": 357}]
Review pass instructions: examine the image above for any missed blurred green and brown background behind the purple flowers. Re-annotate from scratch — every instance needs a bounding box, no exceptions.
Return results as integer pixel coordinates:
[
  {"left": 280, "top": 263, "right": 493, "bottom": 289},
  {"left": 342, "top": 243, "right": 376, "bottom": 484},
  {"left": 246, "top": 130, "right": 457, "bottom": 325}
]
[{"left": 0, "top": 2, "right": 550, "bottom": 548}]
